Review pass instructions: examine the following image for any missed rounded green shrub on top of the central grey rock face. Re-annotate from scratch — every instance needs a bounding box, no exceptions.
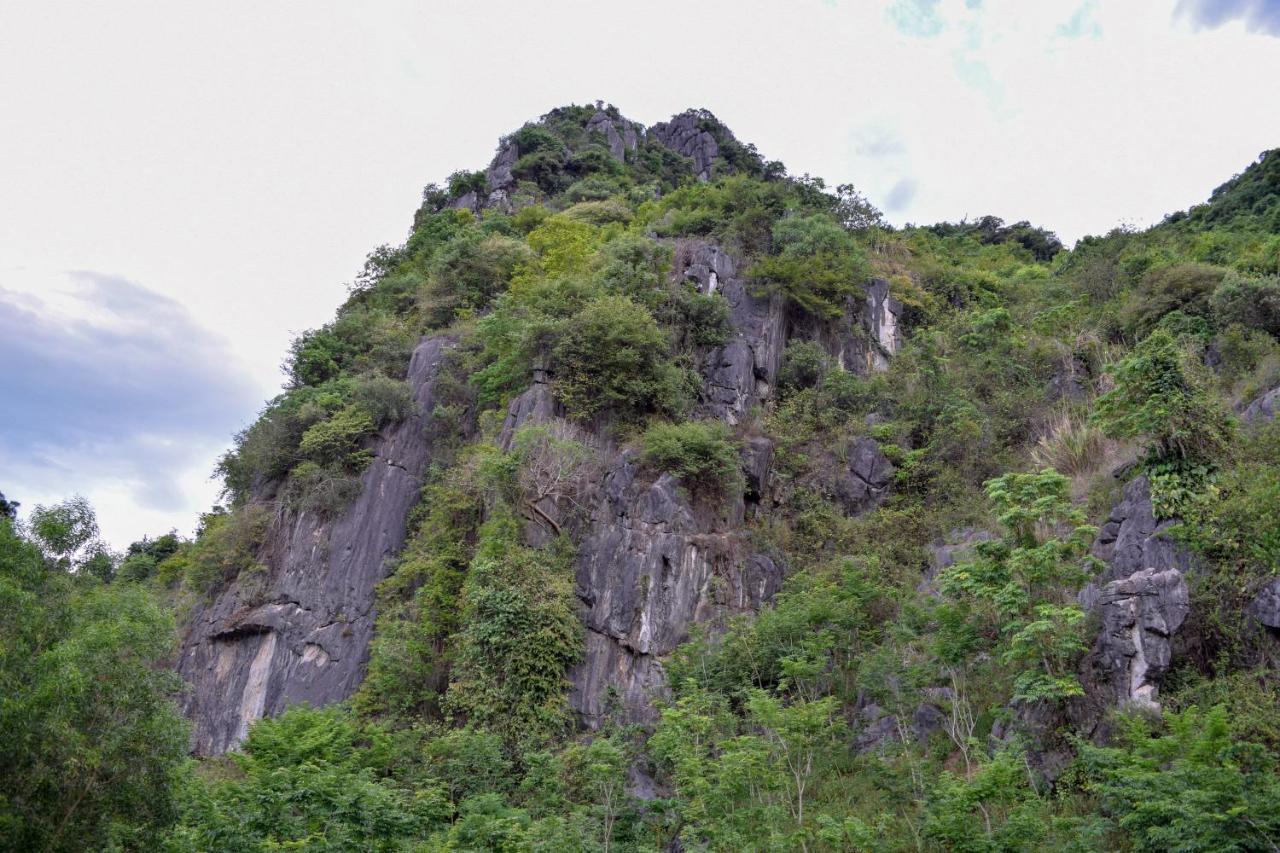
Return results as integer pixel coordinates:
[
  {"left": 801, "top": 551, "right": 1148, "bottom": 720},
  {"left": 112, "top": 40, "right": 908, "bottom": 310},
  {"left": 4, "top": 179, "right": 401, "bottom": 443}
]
[{"left": 641, "top": 420, "right": 741, "bottom": 493}]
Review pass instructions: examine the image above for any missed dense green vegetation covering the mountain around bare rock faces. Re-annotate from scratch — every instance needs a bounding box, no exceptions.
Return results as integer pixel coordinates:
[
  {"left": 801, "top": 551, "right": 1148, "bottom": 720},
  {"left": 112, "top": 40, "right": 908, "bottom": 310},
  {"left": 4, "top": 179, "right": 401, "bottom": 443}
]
[{"left": 0, "top": 108, "right": 1280, "bottom": 850}]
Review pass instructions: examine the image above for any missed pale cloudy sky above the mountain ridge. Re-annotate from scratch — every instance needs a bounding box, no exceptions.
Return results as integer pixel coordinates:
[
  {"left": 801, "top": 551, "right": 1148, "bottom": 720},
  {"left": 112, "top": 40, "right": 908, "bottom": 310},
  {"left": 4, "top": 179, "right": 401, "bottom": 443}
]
[{"left": 0, "top": 0, "right": 1280, "bottom": 548}]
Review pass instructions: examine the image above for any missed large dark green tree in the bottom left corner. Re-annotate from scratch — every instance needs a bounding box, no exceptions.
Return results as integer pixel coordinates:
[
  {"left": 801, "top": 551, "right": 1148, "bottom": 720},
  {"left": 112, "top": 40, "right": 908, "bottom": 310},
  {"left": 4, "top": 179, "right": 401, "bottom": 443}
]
[{"left": 0, "top": 519, "right": 187, "bottom": 850}]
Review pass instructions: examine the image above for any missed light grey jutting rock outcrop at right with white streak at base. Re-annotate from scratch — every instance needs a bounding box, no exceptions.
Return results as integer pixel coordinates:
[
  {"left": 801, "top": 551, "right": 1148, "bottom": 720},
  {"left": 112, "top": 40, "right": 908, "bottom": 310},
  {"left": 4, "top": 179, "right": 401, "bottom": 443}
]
[{"left": 1085, "top": 569, "right": 1190, "bottom": 710}]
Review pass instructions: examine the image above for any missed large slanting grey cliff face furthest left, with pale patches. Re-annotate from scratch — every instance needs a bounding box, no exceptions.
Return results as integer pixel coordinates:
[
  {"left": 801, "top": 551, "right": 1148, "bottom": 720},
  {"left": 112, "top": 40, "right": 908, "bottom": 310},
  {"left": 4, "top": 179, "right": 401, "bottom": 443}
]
[{"left": 178, "top": 337, "right": 452, "bottom": 754}]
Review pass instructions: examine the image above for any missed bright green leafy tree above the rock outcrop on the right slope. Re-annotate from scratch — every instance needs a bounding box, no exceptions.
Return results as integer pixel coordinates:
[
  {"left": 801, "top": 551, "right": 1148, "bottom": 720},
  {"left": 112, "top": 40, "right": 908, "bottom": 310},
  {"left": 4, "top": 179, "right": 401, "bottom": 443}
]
[{"left": 1093, "top": 330, "right": 1233, "bottom": 460}]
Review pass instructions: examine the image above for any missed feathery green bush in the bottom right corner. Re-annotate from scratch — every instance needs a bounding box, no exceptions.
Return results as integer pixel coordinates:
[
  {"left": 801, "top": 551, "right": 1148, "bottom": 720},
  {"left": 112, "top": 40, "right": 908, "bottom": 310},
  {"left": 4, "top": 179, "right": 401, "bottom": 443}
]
[{"left": 1080, "top": 707, "right": 1280, "bottom": 852}]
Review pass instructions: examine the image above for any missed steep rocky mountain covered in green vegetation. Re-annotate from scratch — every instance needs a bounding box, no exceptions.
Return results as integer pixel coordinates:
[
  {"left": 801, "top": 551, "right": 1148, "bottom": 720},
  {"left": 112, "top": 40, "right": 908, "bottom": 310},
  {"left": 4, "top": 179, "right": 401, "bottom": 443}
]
[{"left": 0, "top": 104, "right": 1280, "bottom": 850}]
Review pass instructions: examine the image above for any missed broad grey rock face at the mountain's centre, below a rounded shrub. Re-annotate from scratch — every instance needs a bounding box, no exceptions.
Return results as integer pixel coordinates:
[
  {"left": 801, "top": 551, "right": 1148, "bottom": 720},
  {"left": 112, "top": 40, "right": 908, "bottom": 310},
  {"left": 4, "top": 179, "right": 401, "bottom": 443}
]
[{"left": 570, "top": 452, "right": 782, "bottom": 727}]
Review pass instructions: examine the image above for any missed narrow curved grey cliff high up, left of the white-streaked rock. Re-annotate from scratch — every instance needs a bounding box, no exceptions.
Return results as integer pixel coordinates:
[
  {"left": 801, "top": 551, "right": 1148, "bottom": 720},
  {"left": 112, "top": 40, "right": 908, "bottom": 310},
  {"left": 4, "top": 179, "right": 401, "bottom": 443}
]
[{"left": 672, "top": 240, "right": 787, "bottom": 424}]
